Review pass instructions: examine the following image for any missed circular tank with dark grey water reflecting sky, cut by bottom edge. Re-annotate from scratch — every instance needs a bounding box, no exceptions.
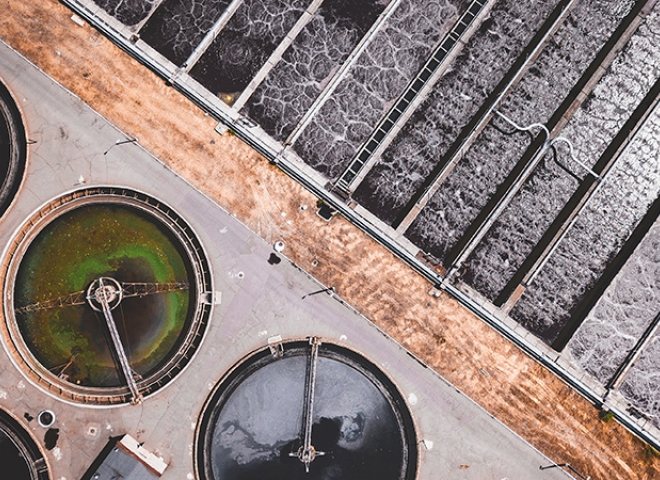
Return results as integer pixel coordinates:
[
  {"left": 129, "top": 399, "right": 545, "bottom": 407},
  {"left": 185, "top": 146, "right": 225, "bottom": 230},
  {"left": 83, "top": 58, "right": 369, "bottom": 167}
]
[{"left": 195, "top": 338, "right": 417, "bottom": 480}]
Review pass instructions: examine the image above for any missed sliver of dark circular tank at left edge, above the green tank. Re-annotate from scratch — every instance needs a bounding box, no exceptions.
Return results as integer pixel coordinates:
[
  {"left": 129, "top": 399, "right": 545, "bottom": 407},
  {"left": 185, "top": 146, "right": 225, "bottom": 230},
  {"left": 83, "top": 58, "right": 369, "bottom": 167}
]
[{"left": 0, "top": 82, "right": 27, "bottom": 216}]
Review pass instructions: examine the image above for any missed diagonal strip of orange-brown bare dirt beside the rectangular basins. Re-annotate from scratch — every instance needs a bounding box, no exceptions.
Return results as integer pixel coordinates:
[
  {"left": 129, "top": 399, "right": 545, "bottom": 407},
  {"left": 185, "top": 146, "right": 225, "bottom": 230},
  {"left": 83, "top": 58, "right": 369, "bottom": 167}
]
[{"left": 0, "top": 0, "right": 660, "bottom": 480}]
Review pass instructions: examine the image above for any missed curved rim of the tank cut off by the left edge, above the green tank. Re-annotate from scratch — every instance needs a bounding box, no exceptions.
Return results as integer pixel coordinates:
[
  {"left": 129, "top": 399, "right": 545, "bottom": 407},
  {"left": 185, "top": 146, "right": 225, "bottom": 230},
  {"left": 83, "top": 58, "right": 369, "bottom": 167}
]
[{"left": 0, "top": 78, "right": 28, "bottom": 219}]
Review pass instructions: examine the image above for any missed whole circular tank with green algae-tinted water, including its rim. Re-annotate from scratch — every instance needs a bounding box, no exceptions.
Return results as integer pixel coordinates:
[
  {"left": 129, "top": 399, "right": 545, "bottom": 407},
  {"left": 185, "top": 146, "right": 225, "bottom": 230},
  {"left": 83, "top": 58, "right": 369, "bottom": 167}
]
[{"left": 5, "top": 188, "right": 211, "bottom": 403}]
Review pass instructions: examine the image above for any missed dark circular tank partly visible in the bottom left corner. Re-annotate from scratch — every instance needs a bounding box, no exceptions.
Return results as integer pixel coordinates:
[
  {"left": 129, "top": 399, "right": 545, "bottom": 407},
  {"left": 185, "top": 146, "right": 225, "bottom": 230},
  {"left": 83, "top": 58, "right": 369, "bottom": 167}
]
[{"left": 0, "top": 410, "right": 48, "bottom": 480}]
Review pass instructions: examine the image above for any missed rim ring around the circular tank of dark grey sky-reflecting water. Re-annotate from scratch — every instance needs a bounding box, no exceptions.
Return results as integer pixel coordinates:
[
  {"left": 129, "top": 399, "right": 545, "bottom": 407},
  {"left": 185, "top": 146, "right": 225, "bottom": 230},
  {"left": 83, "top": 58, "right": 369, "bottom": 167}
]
[{"left": 193, "top": 337, "right": 420, "bottom": 480}]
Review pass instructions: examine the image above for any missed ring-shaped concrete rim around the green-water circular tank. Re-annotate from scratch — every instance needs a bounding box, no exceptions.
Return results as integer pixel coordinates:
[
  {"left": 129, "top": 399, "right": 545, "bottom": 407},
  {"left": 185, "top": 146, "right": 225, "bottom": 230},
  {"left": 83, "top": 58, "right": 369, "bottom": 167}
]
[{"left": 0, "top": 185, "right": 213, "bottom": 408}]
